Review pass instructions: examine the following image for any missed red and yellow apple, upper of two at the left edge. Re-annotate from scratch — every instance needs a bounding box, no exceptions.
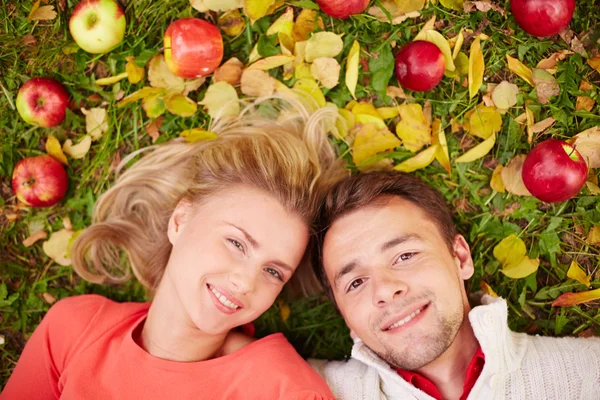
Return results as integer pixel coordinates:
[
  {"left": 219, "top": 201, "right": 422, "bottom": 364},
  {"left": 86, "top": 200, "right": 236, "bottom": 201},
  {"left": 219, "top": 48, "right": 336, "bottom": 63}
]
[{"left": 17, "top": 78, "right": 69, "bottom": 128}]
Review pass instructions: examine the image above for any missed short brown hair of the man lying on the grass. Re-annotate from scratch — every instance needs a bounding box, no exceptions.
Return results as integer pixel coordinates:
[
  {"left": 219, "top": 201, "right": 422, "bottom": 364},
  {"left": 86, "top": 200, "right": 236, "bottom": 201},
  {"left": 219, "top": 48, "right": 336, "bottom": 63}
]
[{"left": 312, "top": 172, "right": 456, "bottom": 302}]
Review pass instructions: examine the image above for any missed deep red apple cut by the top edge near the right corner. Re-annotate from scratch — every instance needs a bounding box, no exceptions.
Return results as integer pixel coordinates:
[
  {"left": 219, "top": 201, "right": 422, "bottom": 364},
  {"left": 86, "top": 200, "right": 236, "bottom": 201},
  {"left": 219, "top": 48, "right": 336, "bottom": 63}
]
[{"left": 510, "top": 0, "right": 575, "bottom": 37}]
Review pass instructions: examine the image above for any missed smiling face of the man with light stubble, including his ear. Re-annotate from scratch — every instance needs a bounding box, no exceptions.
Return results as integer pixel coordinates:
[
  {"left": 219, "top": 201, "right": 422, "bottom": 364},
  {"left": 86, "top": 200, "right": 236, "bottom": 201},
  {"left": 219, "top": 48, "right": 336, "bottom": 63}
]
[{"left": 323, "top": 196, "right": 473, "bottom": 370}]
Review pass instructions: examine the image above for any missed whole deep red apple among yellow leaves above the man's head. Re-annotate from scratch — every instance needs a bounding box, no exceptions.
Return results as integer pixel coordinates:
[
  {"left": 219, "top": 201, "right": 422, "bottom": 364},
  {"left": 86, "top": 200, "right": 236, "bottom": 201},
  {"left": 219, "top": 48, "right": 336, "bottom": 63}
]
[{"left": 396, "top": 40, "right": 446, "bottom": 92}]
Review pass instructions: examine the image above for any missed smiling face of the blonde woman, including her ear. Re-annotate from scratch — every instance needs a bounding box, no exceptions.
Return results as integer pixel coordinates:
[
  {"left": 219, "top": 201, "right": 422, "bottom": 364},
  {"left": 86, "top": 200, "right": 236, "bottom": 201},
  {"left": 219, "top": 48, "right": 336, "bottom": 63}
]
[{"left": 161, "top": 185, "right": 308, "bottom": 335}]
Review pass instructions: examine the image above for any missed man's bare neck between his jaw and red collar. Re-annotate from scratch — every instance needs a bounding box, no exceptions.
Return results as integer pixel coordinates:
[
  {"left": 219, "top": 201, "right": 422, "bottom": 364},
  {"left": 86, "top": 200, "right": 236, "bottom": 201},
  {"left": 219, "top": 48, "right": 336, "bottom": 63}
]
[{"left": 416, "top": 312, "right": 479, "bottom": 400}]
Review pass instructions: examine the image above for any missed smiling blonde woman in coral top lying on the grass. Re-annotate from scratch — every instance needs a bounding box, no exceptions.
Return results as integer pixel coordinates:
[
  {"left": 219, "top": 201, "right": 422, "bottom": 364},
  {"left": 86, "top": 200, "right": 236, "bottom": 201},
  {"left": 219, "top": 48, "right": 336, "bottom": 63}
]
[{"left": 0, "top": 94, "right": 342, "bottom": 400}]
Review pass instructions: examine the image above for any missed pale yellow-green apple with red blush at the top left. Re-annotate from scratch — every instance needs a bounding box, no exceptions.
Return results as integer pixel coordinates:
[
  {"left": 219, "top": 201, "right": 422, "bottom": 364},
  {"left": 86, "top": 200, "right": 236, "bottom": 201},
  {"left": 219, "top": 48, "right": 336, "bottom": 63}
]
[{"left": 69, "top": 0, "right": 126, "bottom": 54}]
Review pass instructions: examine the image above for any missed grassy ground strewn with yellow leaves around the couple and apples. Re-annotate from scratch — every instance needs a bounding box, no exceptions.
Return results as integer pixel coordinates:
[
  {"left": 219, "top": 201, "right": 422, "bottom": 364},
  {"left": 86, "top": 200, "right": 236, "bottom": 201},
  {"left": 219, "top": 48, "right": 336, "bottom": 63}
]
[{"left": 0, "top": 0, "right": 600, "bottom": 384}]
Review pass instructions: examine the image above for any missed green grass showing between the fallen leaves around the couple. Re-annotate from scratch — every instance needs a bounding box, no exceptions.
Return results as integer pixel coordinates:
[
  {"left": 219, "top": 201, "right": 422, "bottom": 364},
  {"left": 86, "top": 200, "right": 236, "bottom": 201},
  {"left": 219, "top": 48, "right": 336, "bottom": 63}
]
[{"left": 0, "top": 0, "right": 600, "bottom": 385}]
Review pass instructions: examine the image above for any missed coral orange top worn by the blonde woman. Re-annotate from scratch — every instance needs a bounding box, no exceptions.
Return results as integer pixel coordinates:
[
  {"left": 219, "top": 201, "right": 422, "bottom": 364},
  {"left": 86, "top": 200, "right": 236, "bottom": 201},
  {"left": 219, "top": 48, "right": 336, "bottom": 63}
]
[{"left": 0, "top": 295, "right": 334, "bottom": 400}]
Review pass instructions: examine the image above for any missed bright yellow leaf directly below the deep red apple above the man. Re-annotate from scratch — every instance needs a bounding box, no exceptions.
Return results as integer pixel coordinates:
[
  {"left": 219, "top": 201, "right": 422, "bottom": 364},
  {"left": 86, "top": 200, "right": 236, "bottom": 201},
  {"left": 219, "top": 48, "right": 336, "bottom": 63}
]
[{"left": 396, "top": 104, "right": 431, "bottom": 153}]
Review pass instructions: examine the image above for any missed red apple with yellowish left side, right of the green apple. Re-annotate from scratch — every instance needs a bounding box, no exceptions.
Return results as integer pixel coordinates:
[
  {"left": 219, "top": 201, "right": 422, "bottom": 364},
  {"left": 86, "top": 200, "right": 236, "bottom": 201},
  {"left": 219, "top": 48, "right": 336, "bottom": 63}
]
[{"left": 164, "top": 18, "right": 223, "bottom": 78}]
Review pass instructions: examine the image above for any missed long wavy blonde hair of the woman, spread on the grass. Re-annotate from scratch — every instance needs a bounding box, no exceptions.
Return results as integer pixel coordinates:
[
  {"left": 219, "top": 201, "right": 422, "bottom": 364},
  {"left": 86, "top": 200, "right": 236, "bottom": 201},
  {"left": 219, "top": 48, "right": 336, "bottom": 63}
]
[{"left": 71, "top": 94, "right": 345, "bottom": 295}]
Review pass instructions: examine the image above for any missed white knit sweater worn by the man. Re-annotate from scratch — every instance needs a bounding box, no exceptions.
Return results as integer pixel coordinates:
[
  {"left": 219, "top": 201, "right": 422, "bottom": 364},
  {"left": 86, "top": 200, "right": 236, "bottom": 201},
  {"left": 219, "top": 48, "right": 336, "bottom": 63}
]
[{"left": 309, "top": 295, "right": 600, "bottom": 400}]
